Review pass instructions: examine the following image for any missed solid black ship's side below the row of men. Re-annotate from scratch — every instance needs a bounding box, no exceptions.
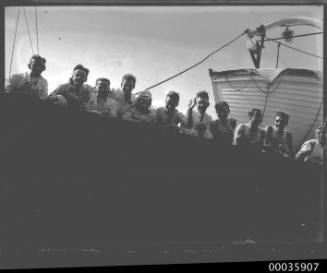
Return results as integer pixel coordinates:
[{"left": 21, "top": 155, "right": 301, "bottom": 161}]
[{"left": 0, "top": 94, "right": 322, "bottom": 266}]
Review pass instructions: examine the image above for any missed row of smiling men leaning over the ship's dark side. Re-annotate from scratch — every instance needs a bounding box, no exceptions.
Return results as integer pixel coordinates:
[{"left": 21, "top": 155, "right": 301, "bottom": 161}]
[{"left": 6, "top": 55, "right": 326, "bottom": 165}]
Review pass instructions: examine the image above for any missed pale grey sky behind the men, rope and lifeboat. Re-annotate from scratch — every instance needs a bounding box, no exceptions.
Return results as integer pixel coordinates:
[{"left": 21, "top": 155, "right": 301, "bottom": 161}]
[{"left": 5, "top": 6, "right": 323, "bottom": 116}]
